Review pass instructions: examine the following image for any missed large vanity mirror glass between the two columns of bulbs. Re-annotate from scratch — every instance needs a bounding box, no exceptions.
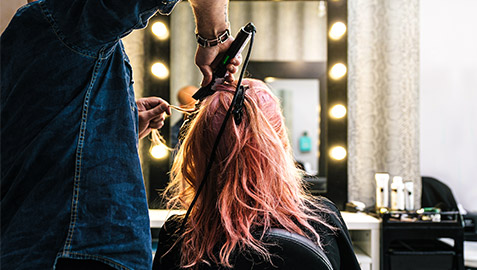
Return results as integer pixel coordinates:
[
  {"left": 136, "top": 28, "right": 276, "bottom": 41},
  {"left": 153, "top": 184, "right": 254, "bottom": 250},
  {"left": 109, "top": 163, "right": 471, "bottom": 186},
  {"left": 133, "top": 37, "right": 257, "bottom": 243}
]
[{"left": 144, "top": 1, "right": 327, "bottom": 207}]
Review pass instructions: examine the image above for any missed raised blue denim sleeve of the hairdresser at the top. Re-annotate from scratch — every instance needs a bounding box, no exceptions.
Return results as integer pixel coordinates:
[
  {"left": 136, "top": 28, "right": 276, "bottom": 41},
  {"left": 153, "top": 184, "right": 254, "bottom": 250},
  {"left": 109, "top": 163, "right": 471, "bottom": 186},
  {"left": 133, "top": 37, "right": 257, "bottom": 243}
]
[{"left": 42, "top": 0, "right": 180, "bottom": 55}]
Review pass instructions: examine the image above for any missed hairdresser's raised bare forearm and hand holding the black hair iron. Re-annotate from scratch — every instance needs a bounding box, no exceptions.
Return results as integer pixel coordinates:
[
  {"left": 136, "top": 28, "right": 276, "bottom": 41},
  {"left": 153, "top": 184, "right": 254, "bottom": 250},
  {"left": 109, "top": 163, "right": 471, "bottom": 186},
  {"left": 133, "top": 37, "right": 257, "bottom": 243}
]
[{"left": 189, "top": 0, "right": 241, "bottom": 85}]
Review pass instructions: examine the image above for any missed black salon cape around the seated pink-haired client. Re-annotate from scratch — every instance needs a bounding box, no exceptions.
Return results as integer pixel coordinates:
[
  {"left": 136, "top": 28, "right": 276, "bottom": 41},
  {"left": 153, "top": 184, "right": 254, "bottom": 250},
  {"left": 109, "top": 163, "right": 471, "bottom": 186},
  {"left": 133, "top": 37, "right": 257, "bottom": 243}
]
[{"left": 153, "top": 198, "right": 361, "bottom": 270}]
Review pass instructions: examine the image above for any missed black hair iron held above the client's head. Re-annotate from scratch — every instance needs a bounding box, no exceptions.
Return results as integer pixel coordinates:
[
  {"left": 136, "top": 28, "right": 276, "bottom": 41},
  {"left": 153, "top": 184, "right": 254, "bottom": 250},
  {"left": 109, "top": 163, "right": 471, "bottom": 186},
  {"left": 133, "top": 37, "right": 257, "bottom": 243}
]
[{"left": 192, "top": 22, "right": 257, "bottom": 100}]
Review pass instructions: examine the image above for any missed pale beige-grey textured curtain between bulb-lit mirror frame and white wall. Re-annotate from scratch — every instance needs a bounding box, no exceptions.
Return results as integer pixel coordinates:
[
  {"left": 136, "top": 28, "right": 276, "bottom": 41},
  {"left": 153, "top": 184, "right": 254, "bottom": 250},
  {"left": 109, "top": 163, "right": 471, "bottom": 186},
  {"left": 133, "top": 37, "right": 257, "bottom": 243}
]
[{"left": 348, "top": 0, "right": 421, "bottom": 208}]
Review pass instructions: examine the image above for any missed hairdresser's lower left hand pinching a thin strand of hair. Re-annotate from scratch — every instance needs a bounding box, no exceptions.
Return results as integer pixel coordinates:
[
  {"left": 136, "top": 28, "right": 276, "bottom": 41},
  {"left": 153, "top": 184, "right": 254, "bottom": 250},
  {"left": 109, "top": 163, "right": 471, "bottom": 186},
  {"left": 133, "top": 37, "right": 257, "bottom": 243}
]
[{"left": 136, "top": 97, "right": 171, "bottom": 139}]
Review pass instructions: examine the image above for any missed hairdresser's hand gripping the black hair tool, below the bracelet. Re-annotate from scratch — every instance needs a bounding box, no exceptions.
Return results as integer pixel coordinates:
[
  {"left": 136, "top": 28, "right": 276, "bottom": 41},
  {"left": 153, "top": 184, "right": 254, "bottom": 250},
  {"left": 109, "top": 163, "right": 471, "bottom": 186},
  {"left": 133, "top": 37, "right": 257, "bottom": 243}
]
[{"left": 195, "top": 37, "right": 242, "bottom": 86}]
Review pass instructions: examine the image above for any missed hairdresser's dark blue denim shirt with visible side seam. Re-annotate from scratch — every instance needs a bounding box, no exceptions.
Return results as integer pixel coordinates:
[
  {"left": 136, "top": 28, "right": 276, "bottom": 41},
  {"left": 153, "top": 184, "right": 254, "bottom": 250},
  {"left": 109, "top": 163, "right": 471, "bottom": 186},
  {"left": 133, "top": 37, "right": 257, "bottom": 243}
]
[{"left": 0, "top": 0, "right": 179, "bottom": 270}]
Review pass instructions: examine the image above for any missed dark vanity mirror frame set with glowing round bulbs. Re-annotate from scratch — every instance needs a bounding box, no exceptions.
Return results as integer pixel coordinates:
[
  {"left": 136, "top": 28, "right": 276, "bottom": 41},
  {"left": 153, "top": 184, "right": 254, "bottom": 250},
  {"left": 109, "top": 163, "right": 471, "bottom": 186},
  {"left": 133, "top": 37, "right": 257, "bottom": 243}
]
[{"left": 141, "top": 0, "right": 348, "bottom": 210}]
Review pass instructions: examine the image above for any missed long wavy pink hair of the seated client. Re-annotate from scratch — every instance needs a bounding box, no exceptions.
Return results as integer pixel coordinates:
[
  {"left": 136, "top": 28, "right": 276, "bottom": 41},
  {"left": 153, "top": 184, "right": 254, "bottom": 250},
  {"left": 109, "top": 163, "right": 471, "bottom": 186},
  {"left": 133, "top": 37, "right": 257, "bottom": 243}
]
[{"left": 166, "top": 79, "right": 334, "bottom": 268}]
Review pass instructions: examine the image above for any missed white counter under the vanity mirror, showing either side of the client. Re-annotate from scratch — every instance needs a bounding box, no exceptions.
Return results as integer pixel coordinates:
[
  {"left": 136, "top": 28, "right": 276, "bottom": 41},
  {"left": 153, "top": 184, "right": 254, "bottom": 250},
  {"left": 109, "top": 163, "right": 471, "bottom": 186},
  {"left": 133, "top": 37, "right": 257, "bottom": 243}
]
[{"left": 149, "top": 209, "right": 381, "bottom": 270}]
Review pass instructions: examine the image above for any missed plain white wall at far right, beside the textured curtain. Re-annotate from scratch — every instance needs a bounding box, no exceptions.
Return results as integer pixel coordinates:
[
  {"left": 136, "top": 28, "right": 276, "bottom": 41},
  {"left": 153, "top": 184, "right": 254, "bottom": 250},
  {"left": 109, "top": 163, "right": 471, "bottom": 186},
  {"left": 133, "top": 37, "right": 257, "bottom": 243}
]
[{"left": 420, "top": 0, "right": 477, "bottom": 211}]
